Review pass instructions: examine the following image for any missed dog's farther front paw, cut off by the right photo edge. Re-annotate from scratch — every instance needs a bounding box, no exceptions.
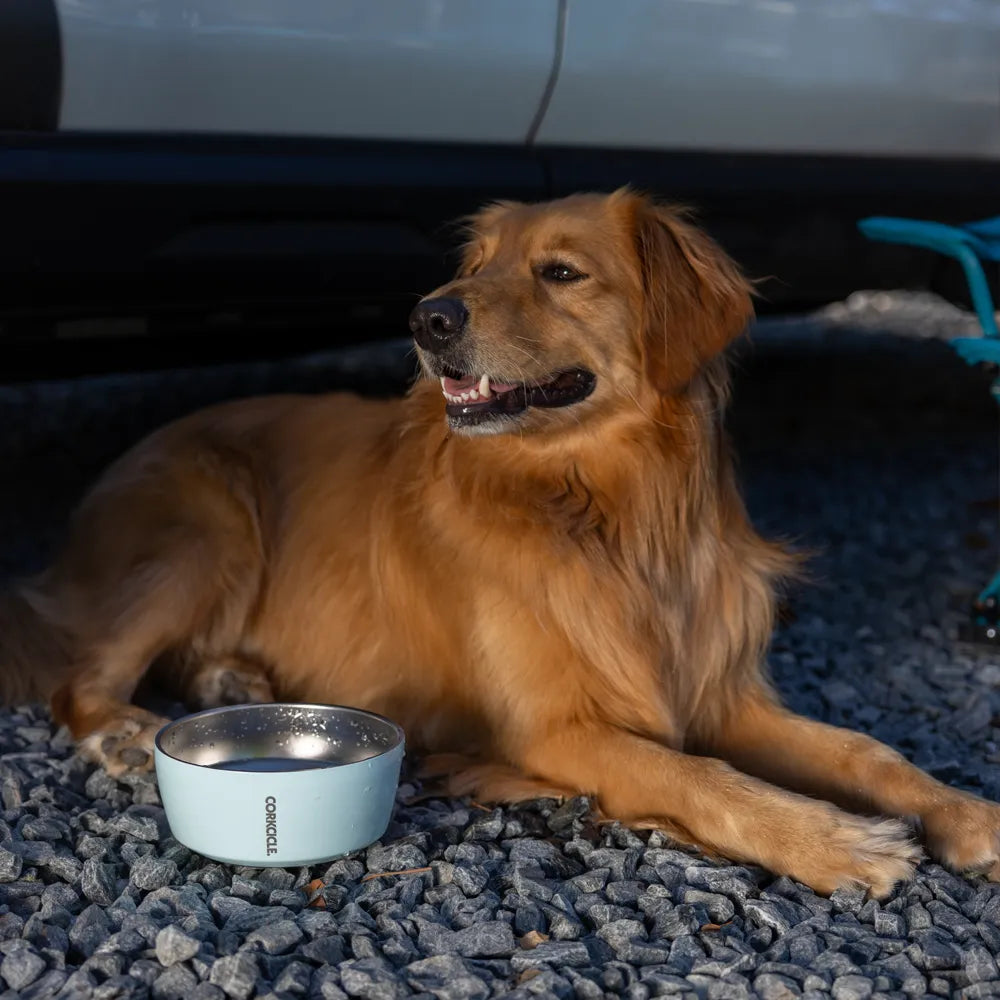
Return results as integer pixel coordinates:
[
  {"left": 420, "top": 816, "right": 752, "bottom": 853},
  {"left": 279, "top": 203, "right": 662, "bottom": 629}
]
[{"left": 920, "top": 790, "right": 1000, "bottom": 882}]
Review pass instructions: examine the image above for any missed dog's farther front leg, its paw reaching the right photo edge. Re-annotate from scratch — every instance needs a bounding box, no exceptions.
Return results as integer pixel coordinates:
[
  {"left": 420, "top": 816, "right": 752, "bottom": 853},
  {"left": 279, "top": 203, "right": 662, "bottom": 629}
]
[{"left": 702, "top": 691, "right": 1000, "bottom": 881}]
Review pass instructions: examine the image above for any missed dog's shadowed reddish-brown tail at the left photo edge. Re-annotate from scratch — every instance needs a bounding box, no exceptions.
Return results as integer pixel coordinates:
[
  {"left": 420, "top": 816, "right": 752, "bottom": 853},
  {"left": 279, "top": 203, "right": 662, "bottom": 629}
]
[{"left": 0, "top": 587, "right": 70, "bottom": 705}]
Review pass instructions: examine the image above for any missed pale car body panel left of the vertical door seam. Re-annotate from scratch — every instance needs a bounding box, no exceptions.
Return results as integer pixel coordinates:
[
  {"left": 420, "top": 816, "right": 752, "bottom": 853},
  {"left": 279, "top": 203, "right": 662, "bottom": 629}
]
[{"left": 57, "top": 0, "right": 558, "bottom": 143}]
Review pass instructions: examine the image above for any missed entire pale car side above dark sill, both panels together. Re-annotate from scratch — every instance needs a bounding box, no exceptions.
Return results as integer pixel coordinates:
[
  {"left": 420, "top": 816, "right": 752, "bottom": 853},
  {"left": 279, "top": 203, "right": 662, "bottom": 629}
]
[{"left": 50, "top": 0, "right": 1000, "bottom": 159}]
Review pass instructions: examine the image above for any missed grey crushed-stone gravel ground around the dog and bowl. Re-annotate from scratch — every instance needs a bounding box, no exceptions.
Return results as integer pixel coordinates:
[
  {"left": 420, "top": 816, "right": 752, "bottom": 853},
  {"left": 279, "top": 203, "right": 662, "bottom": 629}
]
[{"left": 0, "top": 295, "right": 1000, "bottom": 1000}]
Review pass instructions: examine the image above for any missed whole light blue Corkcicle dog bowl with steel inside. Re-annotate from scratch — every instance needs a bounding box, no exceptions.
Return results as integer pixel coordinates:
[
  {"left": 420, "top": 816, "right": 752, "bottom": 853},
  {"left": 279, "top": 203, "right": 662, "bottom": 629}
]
[{"left": 154, "top": 703, "right": 404, "bottom": 868}]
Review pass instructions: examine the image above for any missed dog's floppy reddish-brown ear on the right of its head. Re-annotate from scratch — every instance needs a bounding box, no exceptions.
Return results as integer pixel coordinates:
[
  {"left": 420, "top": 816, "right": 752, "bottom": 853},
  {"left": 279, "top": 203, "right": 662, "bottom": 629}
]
[{"left": 630, "top": 195, "right": 753, "bottom": 394}]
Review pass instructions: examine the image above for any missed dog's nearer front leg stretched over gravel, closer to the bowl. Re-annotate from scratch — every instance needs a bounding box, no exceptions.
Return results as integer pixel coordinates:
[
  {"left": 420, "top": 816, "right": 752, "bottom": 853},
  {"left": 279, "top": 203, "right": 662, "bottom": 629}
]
[{"left": 517, "top": 722, "right": 919, "bottom": 896}]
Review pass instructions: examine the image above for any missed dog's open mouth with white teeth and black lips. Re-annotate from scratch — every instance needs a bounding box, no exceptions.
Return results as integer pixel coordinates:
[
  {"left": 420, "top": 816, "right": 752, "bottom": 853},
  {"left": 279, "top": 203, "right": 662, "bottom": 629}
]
[{"left": 441, "top": 367, "right": 597, "bottom": 426}]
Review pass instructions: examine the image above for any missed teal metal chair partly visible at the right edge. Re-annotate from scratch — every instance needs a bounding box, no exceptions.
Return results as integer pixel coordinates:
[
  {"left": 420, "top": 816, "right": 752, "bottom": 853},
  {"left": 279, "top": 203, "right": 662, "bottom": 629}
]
[{"left": 858, "top": 215, "right": 1000, "bottom": 643}]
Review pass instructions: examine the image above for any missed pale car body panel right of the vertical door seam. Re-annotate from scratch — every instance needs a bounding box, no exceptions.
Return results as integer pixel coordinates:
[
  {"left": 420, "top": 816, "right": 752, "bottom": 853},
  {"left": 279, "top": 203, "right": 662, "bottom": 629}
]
[{"left": 537, "top": 0, "right": 1000, "bottom": 158}]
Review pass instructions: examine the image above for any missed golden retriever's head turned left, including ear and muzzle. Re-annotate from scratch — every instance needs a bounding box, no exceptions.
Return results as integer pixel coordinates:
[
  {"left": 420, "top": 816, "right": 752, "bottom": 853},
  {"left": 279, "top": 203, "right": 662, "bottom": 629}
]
[{"left": 410, "top": 189, "right": 751, "bottom": 433}]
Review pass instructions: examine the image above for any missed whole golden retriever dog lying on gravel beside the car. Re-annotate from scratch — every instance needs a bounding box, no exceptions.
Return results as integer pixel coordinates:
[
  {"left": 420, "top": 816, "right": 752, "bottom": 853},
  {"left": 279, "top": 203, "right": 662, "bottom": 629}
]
[{"left": 0, "top": 190, "right": 1000, "bottom": 896}]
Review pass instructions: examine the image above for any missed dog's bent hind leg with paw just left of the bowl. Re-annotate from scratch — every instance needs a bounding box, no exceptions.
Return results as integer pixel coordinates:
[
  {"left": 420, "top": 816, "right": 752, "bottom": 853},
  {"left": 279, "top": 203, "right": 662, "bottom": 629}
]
[{"left": 47, "top": 450, "right": 263, "bottom": 775}]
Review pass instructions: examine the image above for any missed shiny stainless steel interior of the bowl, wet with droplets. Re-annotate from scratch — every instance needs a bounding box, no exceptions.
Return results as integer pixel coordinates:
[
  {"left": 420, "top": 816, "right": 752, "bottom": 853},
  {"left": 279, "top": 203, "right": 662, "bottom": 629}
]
[{"left": 156, "top": 704, "right": 403, "bottom": 771}]
